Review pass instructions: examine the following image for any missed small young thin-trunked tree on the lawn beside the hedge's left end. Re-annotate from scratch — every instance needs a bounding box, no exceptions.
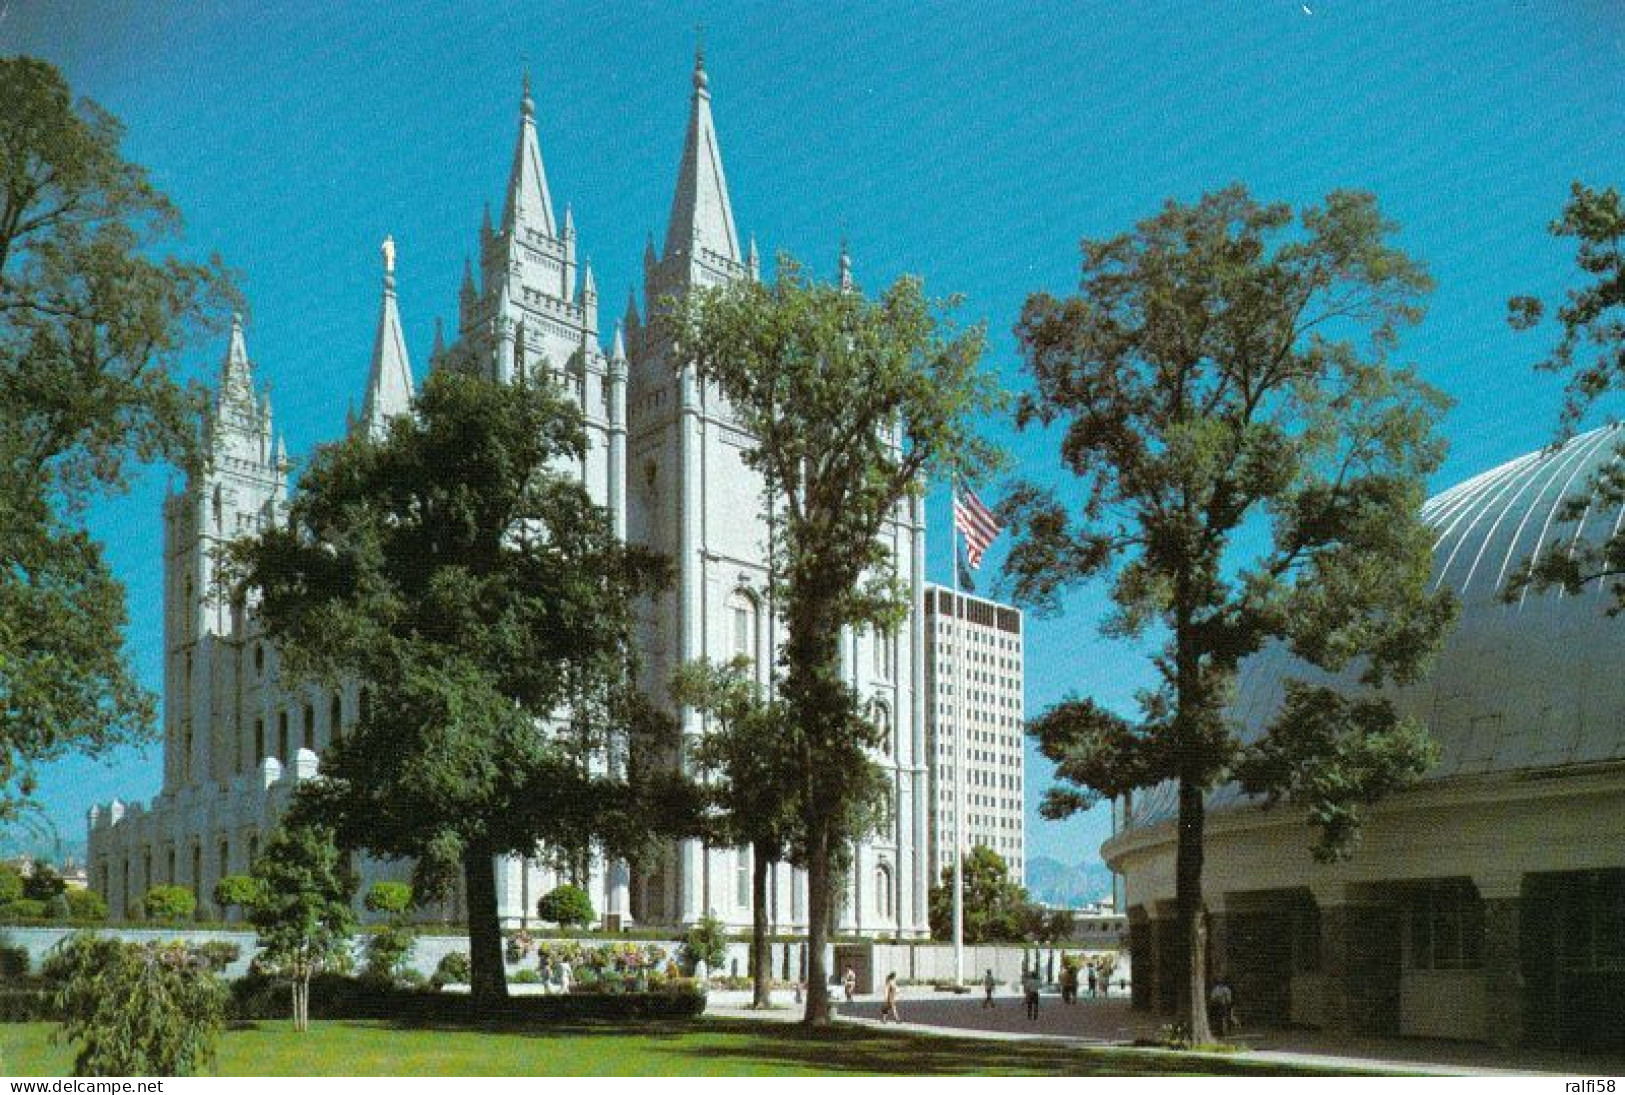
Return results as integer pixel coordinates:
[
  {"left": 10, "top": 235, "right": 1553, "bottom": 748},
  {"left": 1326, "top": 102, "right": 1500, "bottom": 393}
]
[{"left": 249, "top": 815, "right": 356, "bottom": 1030}]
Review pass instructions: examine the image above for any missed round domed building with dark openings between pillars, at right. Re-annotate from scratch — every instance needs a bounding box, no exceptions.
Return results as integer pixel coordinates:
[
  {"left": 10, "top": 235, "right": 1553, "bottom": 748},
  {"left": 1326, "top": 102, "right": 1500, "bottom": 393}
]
[{"left": 1102, "top": 426, "right": 1625, "bottom": 1050}]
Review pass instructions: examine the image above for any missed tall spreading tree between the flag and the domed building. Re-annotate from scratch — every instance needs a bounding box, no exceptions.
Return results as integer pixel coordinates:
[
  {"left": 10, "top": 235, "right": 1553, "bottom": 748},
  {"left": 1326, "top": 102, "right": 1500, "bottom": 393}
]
[{"left": 1008, "top": 187, "right": 1454, "bottom": 1041}]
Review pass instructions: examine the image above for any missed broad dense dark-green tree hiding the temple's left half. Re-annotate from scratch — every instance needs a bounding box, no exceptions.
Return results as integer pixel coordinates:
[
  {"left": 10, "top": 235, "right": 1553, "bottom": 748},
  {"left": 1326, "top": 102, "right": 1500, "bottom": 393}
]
[{"left": 229, "top": 372, "right": 670, "bottom": 998}]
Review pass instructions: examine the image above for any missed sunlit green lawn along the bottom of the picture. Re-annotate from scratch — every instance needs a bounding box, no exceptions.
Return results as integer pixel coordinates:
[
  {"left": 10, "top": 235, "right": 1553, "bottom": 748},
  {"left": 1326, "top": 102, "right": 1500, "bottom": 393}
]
[{"left": 0, "top": 1019, "right": 1371, "bottom": 1076}]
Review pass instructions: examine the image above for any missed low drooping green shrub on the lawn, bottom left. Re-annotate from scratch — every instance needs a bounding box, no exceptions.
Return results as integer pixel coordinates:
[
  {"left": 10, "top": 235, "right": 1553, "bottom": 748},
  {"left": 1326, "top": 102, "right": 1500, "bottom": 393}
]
[{"left": 44, "top": 933, "right": 226, "bottom": 1076}]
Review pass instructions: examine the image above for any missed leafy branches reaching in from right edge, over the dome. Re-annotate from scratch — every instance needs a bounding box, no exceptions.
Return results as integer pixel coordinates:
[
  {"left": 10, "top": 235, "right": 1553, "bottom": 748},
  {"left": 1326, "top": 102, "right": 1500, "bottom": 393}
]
[{"left": 1505, "top": 182, "right": 1625, "bottom": 604}]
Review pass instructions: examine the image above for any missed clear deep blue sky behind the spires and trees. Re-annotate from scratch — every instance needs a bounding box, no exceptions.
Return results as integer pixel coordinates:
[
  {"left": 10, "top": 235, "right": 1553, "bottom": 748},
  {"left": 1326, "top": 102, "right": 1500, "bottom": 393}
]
[{"left": 0, "top": 0, "right": 1625, "bottom": 863}]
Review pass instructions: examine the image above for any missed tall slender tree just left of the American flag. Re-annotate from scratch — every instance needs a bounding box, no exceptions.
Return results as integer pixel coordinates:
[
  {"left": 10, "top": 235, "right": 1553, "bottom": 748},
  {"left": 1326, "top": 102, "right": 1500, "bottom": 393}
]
[{"left": 657, "top": 257, "right": 998, "bottom": 1024}]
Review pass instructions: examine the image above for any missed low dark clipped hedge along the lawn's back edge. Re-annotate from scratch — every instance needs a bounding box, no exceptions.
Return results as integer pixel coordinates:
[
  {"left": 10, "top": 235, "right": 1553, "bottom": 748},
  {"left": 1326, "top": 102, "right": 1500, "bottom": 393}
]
[{"left": 228, "top": 975, "right": 705, "bottom": 1025}]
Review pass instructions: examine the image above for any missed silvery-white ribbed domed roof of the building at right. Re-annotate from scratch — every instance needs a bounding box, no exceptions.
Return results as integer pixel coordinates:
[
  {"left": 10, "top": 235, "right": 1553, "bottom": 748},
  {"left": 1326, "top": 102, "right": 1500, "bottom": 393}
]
[{"left": 1134, "top": 426, "right": 1625, "bottom": 824}]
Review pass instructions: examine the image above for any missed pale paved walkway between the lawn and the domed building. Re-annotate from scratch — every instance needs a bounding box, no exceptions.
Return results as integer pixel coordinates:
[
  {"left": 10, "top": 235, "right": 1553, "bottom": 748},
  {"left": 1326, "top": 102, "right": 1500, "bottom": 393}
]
[{"left": 707, "top": 988, "right": 1625, "bottom": 1076}]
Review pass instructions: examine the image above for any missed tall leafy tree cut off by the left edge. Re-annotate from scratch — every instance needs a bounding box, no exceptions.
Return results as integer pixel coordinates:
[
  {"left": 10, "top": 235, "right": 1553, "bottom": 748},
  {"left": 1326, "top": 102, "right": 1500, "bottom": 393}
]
[{"left": 0, "top": 57, "right": 234, "bottom": 820}]
